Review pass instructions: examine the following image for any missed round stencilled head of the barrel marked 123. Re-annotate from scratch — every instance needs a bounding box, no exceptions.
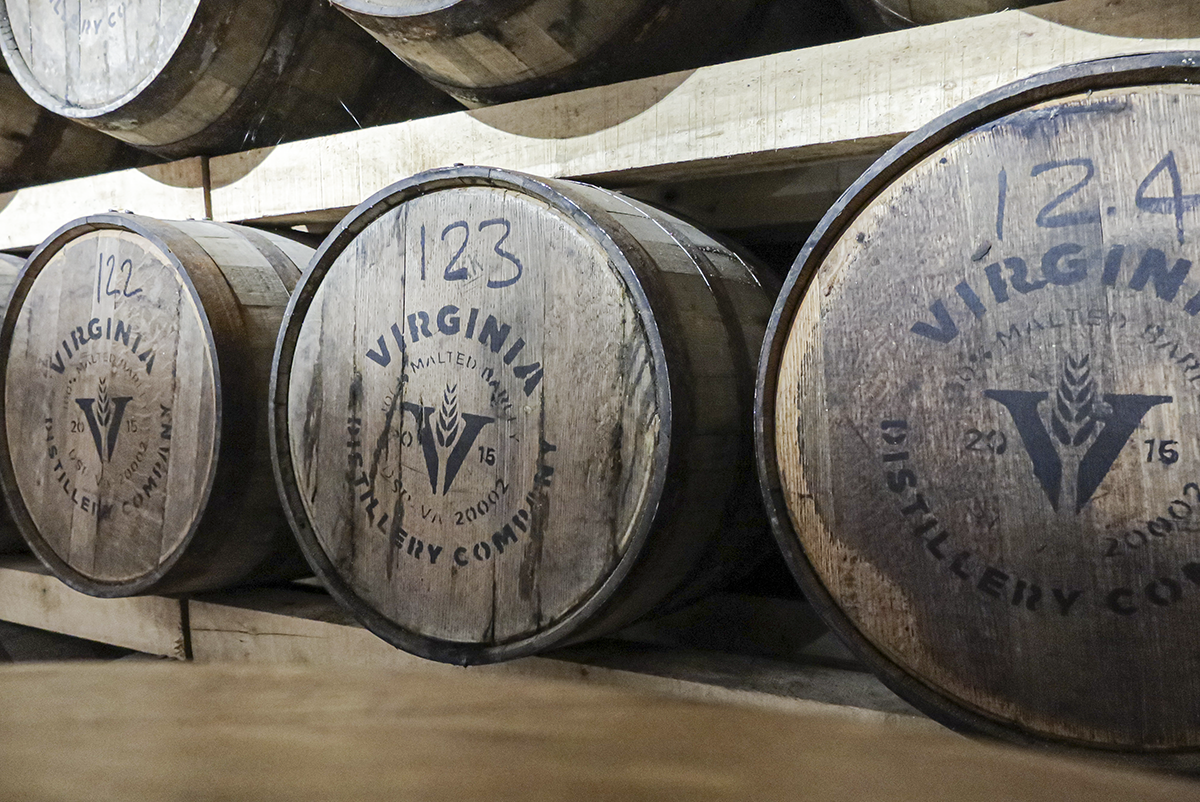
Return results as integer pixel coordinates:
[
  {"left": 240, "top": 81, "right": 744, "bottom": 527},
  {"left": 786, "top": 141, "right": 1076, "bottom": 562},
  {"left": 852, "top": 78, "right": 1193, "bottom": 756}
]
[{"left": 274, "top": 168, "right": 670, "bottom": 662}]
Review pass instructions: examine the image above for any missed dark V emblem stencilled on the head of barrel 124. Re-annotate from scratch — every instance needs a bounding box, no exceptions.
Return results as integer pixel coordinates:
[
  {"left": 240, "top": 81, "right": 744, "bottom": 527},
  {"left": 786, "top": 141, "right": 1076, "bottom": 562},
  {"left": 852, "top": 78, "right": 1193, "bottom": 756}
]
[{"left": 984, "top": 388, "right": 1172, "bottom": 515}]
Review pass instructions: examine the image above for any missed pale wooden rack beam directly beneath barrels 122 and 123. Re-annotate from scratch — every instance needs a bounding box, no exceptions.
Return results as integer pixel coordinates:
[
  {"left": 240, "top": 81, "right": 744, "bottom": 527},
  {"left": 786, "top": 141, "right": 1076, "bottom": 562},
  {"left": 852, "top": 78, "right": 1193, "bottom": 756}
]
[{"left": 0, "top": 556, "right": 916, "bottom": 725}]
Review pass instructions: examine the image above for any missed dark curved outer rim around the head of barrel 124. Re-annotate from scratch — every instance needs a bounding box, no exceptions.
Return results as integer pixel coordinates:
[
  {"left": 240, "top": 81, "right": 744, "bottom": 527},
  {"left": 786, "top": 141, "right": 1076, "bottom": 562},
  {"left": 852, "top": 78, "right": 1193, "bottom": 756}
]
[{"left": 754, "top": 52, "right": 1200, "bottom": 772}]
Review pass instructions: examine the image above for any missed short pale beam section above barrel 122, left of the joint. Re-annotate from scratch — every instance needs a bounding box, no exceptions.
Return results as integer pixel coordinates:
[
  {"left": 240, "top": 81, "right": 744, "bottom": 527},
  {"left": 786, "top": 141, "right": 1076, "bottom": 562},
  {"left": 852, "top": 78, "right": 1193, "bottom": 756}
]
[{"left": 0, "top": 158, "right": 209, "bottom": 249}]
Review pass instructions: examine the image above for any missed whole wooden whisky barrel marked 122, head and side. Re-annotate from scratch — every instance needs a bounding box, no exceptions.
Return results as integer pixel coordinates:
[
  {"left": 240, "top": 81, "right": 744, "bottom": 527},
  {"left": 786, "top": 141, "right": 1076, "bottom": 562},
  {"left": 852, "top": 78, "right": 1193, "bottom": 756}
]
[{"left": 0, "top": 214, "right": 312, "bottom": 597}]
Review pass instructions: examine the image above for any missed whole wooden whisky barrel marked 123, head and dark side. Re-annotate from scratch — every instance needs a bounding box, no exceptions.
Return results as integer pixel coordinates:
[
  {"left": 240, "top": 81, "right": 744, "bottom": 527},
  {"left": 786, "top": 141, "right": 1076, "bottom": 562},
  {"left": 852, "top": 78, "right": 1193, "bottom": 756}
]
[{"left": 271, "top": 167, "right": 770, "bottom": 664}]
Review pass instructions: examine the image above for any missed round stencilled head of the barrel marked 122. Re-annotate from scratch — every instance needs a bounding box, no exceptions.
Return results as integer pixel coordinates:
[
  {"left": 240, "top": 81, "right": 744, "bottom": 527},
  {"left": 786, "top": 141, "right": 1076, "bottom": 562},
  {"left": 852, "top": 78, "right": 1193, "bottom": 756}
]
[{"left": 4, "top": 221, "right": 221, "bottom": 594}]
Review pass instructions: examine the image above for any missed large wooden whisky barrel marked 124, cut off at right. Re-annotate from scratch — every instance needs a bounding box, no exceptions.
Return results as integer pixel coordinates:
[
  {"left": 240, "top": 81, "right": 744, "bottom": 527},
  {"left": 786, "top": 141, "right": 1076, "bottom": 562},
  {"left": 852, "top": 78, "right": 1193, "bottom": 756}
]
[{"left": 756, "top": 53, "right": 1200, "bottom": 762}]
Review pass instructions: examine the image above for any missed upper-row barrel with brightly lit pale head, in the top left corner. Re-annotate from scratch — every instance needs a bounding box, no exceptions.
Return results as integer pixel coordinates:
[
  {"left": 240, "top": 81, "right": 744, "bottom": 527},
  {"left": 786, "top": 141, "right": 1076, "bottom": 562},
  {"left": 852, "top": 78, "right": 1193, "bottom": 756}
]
[{"left": 0, "top": 0, "right": 452, "bottom": 157}]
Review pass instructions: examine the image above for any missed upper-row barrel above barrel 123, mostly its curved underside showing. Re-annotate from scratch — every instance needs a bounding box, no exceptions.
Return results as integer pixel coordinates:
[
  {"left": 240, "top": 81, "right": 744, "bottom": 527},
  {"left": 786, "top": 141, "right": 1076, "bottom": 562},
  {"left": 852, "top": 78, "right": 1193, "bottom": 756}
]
[{"left": 332, "top": 0, "right": 762, "bottom": 106}]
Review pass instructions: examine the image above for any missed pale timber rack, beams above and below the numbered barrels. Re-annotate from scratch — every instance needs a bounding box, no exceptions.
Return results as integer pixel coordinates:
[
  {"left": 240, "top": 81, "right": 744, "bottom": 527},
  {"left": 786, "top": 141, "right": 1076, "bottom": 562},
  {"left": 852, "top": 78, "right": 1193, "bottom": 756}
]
[{"left": 0, "top": 0, "right": 1200, "bottom": 729}]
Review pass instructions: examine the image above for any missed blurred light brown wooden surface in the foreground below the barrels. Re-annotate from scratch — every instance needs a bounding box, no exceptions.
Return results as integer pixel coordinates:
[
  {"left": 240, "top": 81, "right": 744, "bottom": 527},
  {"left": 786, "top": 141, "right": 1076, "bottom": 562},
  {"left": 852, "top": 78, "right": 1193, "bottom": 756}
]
[{"left": 0, "top": 663, "right": 1200, "bottom": 802}]
